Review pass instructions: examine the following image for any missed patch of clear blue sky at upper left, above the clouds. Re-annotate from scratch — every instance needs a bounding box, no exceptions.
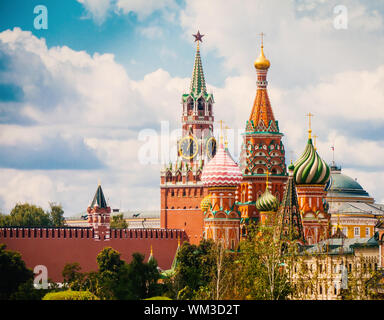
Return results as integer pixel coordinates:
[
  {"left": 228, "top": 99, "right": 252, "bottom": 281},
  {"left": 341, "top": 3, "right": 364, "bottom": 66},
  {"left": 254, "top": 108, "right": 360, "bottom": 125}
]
[{"left": 0, "top": 0, "right": 228, "bottom": 85}]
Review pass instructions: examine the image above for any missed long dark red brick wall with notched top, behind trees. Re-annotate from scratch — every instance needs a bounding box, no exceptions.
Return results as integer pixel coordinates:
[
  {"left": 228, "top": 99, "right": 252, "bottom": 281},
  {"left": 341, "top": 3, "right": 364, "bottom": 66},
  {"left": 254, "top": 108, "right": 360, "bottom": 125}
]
[{"left": 0, "top": 228, "right": 185, "bottom": 282}]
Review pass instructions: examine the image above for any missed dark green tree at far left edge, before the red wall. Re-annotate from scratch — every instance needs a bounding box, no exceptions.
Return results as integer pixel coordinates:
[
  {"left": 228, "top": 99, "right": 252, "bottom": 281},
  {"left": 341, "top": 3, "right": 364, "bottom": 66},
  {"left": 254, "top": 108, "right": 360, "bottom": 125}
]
[{"left": 0, "top": 244, "right": 34, "bottom": 300}]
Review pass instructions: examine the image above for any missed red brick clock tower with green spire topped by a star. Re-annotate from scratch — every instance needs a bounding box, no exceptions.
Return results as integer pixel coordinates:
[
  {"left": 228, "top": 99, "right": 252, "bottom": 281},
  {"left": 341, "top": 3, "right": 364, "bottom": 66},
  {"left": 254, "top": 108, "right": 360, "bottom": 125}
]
[{"left": 160, "top": 31, "right": 216, "bottom": 244}]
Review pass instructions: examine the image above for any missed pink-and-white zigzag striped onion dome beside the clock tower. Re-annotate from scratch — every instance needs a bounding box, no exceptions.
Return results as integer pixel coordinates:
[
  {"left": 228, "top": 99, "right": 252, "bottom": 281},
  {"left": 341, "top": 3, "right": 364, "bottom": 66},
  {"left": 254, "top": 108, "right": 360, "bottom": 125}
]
[{"left": 201, "top": 143, "right": 243, "bottom": 187}]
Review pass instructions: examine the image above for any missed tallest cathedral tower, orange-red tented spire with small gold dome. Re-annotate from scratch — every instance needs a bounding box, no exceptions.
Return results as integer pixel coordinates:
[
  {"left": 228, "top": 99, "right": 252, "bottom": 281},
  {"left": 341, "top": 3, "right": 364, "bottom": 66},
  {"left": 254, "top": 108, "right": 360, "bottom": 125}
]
[{"left": 237, "top": 34, "right": 287, "bottom": 235}]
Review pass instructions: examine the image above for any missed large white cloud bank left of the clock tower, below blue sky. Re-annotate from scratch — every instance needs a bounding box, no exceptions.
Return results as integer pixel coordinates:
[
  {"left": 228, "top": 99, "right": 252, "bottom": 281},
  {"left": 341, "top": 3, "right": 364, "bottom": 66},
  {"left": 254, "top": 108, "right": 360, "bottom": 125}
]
[{"left": 0, "top": 28, "right": 189, "bottom": 215}]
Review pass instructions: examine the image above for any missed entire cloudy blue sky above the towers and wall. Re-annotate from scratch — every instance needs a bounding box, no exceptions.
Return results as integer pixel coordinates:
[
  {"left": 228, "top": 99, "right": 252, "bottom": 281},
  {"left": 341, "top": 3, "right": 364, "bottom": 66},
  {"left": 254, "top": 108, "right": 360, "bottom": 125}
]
[{"left": 0, "top": 0, "right": 384, "bottom": 216}]
